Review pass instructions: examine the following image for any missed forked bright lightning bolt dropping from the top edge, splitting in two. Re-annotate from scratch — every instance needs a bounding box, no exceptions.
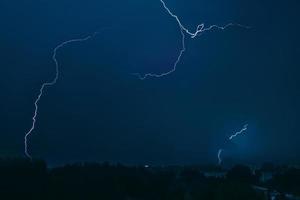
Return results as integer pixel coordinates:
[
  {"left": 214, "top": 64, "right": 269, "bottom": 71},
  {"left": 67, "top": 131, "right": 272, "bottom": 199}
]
[{"left": 132, "top": 0, "right": 250, "bottom": 80}]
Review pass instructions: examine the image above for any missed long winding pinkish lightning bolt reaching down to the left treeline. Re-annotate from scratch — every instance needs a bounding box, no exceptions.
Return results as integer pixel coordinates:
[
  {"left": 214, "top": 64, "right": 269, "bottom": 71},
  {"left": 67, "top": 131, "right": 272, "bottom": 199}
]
[{"left": 24, "top": 32, "right": 98, "bottom": 159}]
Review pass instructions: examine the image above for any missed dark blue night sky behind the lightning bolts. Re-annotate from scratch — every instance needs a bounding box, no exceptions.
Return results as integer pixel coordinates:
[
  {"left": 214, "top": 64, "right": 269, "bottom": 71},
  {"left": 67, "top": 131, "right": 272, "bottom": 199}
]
[{"left": 0, "top": 0, "right": 300, "bottom": 165}]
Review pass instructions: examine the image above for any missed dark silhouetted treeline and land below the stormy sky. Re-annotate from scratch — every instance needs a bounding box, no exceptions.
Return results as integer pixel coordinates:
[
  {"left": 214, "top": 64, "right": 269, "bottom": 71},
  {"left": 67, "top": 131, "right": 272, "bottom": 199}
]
[{"left": 0, "top": 159, "right": 300, "bottom": 200}]
